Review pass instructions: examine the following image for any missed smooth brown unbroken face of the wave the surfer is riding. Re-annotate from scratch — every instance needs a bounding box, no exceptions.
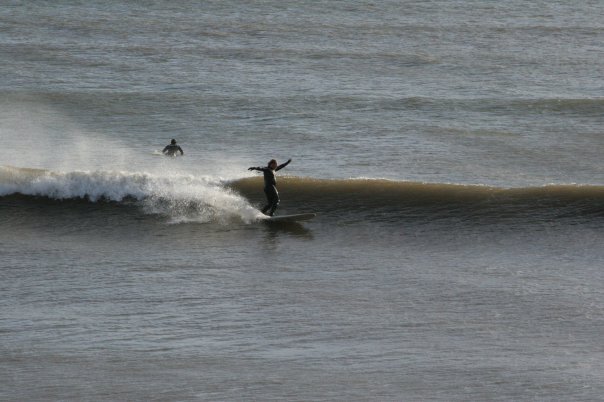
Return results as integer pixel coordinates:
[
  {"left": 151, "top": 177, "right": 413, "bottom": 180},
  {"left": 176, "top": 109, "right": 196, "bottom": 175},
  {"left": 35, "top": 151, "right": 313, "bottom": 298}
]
[{"left": 231, "top": 177, "right": 604, "bottom": 225}]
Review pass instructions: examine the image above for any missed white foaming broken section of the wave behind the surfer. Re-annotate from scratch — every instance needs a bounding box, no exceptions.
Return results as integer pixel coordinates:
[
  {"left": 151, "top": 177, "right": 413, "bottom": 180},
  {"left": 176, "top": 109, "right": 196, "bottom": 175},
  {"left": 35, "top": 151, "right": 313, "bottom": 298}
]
[{"left": 0, "top": 166, "right": 261, "bottom": 223}]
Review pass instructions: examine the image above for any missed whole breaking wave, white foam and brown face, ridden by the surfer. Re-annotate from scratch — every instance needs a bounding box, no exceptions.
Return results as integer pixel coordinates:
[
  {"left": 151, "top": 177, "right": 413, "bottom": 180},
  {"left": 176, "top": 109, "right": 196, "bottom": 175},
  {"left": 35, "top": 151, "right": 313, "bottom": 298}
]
[{"left": 0, "top": 166, "right": 604, "bottom": 223}]
